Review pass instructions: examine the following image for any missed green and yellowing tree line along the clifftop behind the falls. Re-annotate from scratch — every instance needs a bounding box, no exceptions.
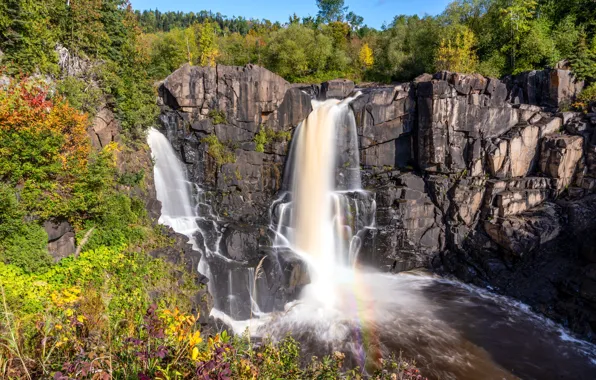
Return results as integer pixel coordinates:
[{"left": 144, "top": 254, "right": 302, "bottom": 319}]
[{"left": 136, "top": 0, "right": 596, "bottom": 82}]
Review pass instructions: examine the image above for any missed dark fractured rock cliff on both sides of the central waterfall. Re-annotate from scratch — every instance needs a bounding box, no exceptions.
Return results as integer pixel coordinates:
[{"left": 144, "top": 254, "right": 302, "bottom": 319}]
[{"left": 159, "top": 65, "right": 596, "bottom": 340}]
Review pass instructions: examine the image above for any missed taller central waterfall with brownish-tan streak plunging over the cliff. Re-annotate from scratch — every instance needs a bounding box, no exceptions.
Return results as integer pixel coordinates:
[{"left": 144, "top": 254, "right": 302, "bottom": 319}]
[{"left": 275, "top": 98, "right": 374, "bottom": 307}]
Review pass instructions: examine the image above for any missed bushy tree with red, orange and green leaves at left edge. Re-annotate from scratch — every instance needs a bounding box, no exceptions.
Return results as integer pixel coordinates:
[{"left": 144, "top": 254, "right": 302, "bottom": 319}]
[{"left": 0, "top": 78, "right": 91, "bottom": 186}]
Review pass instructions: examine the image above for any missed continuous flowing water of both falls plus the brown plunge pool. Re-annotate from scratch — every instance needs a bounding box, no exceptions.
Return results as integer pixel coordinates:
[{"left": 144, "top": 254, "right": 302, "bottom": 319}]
[{"left": 149, "top": 99, "right": 596, "bottom": 380}]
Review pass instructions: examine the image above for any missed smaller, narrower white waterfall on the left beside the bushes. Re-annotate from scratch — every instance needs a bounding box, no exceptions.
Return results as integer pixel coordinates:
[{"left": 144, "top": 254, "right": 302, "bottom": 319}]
[{"left": 147, "top": 128, "right": 262, "bottom": 317}]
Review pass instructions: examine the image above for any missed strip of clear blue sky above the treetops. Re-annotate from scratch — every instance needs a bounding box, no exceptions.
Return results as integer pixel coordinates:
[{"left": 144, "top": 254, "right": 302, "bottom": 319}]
[{"left": 131, "top": 0, "right": 452, "bottom": 28}]
